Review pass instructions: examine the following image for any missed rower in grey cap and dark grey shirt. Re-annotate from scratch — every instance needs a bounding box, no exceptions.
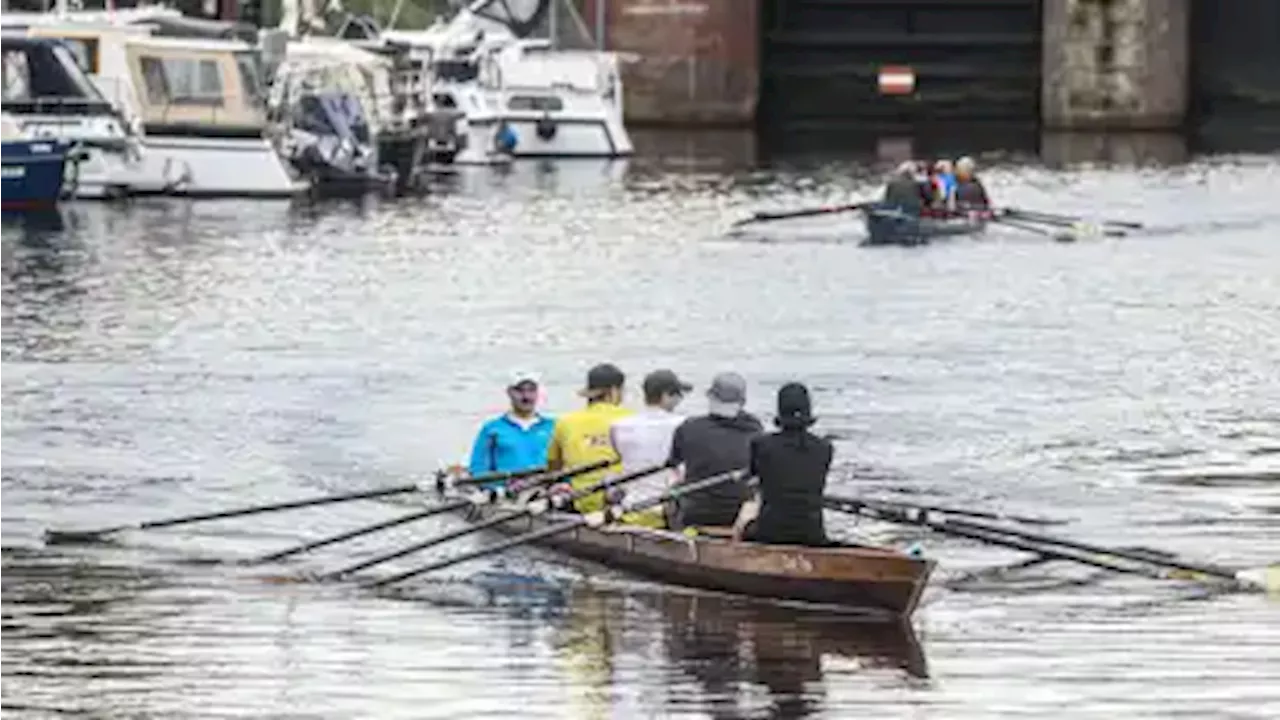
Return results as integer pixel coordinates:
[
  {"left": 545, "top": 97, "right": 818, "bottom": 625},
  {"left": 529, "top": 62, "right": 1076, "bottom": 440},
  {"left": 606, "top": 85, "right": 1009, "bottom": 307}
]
[{"left": 671, "top": 373, "right": 764, "bottom": 528}]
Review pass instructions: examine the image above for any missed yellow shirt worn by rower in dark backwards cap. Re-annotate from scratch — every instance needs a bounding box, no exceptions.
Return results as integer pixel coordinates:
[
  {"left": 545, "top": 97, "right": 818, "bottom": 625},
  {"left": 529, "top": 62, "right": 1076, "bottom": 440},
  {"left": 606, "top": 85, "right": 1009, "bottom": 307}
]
[{"left": 547, "top": 402, "right": 631, "bottom": 512}]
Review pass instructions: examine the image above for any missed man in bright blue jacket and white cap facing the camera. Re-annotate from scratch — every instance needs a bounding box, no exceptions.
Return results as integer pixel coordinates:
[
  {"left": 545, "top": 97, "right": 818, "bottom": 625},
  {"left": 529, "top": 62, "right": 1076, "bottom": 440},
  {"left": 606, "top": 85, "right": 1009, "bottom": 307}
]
[{"left": 467, "top": 373, "right": 556, "bottom": 488}]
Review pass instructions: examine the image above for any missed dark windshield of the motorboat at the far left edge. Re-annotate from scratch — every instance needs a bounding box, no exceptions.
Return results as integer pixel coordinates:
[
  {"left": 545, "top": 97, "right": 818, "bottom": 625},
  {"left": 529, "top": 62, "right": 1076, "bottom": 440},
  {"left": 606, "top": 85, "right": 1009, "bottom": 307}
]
[{"left": 0, "top": 42, "right": 106, "bottom": 105}]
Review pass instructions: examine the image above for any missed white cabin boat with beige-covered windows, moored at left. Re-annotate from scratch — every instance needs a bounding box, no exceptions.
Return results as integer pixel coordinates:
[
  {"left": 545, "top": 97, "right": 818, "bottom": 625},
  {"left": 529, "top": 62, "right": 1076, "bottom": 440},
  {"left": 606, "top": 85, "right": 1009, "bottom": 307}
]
[{"left": 3, "top": 8, "right": 307, "bottom": 197}]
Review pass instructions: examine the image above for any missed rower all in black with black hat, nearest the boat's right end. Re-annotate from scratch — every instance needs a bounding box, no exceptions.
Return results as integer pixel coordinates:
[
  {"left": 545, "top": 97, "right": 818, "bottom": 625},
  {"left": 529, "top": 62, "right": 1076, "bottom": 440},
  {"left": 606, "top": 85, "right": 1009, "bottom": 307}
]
[{"left": 742, "top": 383, "right": 833, "bottom": 547}]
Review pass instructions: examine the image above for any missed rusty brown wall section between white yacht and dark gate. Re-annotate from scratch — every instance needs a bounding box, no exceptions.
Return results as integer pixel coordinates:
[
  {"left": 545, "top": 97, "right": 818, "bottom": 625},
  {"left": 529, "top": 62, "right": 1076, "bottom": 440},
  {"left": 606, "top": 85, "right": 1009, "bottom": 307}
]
[{"left": 584, "top": 0, "right": 759, "bottom": 126}]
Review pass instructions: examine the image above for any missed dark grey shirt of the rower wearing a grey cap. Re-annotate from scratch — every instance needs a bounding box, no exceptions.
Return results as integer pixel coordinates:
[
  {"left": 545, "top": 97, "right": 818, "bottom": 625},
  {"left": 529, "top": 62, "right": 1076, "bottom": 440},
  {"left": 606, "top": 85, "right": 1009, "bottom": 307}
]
[{"left": 671, "top": 413, "right": 764, "bottom": 527}]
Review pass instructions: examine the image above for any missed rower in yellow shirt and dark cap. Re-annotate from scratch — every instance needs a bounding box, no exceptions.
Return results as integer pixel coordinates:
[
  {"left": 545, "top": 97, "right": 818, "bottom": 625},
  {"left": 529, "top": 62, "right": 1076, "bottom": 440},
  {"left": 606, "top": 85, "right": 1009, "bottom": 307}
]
[{"left": 547, "top": 363, "right": 631, "bottom": 512}]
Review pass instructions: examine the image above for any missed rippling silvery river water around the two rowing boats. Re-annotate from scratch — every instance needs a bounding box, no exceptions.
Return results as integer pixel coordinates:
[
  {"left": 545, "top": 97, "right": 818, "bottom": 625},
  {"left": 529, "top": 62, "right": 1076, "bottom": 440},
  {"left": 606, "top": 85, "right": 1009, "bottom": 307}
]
[{"left": 0, "top": 131, "right": 1280, "bottom": 719}]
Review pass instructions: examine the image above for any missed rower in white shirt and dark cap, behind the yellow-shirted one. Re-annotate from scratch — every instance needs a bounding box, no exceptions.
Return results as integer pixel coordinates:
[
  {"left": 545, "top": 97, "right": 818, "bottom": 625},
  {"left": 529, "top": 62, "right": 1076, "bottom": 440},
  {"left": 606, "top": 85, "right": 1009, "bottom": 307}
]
[{"left": 609, "top": 370, "right": 694, "bottom": 528}]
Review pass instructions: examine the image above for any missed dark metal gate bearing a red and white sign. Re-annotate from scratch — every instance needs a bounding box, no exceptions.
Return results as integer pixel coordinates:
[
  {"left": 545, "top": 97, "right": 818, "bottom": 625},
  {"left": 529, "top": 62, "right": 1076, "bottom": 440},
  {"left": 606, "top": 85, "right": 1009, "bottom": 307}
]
[{"left": 758, "top": 0, "right": 1042, "bottom": 129}]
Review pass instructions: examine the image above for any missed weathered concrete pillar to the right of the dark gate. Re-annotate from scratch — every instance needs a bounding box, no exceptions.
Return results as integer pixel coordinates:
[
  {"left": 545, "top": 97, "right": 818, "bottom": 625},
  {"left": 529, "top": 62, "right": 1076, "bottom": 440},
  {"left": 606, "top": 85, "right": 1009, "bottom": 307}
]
[{"left": 1041, "top": 0, "right": 1192, "bottom": 129}]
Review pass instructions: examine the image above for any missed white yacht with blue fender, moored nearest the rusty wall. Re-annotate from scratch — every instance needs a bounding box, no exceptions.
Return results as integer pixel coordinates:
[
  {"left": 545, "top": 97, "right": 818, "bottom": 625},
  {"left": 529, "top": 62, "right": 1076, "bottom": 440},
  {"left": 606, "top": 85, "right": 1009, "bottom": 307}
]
[{"left": 339, "top": 0, "right": 632, "bottom": 164}]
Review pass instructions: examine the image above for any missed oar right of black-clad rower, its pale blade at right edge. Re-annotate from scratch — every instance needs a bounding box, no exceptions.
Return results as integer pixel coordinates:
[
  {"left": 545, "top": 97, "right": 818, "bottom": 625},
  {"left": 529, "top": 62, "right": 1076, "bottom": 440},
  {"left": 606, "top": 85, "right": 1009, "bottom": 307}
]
[{"left": 826, "top": 498, "right": 1280, "bottom": 592}]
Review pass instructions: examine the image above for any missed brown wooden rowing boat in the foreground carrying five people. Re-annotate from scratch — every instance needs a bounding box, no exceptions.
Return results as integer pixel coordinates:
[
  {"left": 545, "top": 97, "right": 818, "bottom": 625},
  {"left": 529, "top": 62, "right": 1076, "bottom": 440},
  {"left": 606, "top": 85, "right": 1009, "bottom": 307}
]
[{"left": 455, "top": 503, "right": 934, "bottom": 618}]
